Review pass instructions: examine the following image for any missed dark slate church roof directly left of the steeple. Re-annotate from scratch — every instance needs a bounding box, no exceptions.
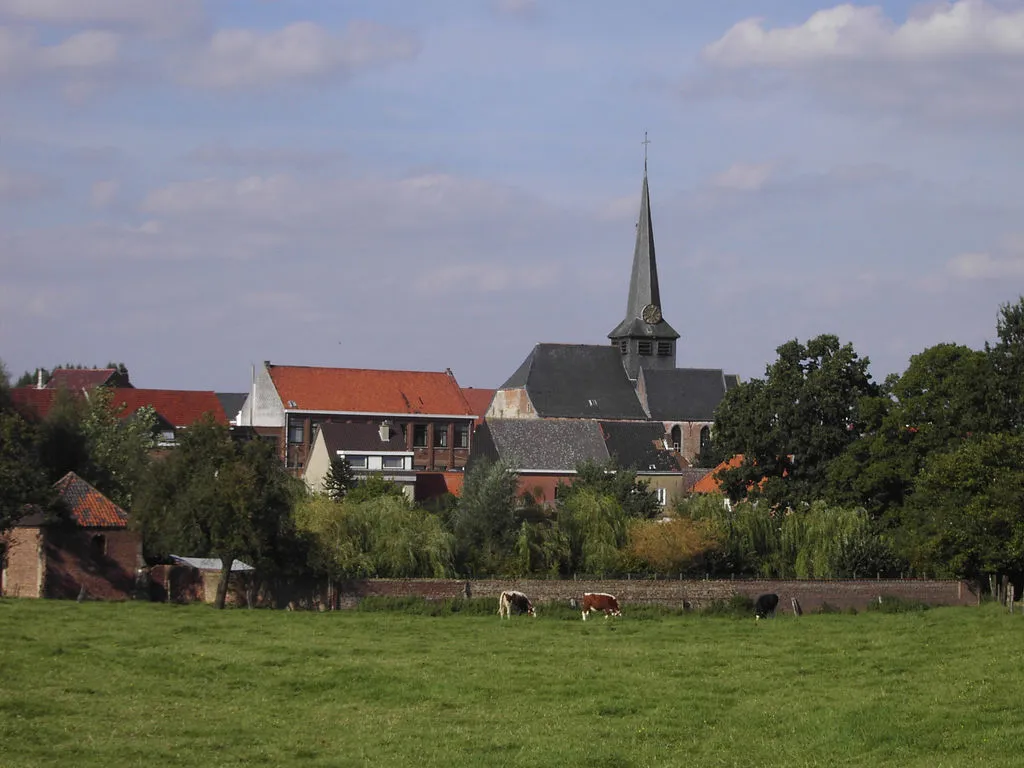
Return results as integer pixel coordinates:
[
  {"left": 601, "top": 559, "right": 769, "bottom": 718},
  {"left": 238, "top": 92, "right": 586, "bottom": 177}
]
[{"left": 502, "top": 344, "right": 647, "bottom": 421}]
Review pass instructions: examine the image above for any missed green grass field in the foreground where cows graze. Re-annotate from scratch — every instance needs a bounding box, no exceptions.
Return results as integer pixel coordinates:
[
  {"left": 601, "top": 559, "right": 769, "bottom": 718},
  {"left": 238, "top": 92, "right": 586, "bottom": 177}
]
[{"left": 0, "top": 599, "right": 1024, "bottom": 768}]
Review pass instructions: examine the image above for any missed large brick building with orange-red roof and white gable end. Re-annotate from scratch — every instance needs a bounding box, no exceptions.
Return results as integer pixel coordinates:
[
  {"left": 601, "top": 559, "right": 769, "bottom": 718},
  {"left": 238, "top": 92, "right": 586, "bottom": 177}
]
[{"left": 239, "top": 360, "right": 476, "bottom": 476}]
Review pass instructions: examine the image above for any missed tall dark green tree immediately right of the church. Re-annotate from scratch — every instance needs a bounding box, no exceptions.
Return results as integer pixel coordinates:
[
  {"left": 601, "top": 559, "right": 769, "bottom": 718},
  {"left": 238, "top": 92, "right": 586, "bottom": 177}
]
[{"left": 714, "top": 335, "right": 878, "bottom": 506}]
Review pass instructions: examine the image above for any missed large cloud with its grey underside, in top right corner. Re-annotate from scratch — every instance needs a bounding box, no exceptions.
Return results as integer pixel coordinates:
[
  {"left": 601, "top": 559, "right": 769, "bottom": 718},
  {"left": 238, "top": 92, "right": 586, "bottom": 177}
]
[{"left": 700, "top": 0, "right": 1024, "bottom": 127}]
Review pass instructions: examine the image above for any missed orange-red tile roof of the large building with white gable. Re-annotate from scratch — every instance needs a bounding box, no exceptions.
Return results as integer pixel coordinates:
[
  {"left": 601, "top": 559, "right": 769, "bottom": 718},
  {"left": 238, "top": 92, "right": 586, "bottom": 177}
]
[{"left": 267, "top": 366, "right": 473, "bottom": 416}]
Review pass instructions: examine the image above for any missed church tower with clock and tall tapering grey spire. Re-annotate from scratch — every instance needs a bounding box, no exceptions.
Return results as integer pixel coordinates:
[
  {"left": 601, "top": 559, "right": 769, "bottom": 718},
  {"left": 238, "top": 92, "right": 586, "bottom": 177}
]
[{"left": 608, "top": 158, "right": 679, "bottom": 381}]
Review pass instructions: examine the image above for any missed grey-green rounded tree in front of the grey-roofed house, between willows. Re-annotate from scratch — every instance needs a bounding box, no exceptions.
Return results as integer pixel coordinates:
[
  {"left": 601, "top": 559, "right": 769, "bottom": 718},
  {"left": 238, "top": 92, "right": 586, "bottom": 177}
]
[{"left": 451, "top": 459, "right": 519, "bottom": 574}]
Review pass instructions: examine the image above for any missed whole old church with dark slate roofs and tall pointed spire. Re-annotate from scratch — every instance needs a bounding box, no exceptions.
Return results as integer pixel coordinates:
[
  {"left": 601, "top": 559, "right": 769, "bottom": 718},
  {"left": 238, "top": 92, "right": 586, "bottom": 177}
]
[{"left": 481, "top": 159, "right": 739, "bottom": 471}]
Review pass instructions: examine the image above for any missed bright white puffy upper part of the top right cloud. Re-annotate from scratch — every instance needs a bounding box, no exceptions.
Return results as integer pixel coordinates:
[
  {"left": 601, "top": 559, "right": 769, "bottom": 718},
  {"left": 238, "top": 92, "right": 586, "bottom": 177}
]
[{"left": 703, "top": 0, "right": 1024, "bottom": 68}]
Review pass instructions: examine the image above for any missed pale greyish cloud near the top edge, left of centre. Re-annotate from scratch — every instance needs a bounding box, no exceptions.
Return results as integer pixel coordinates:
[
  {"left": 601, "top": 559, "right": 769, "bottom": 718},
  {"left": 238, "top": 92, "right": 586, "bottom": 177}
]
[{"left": 181, "top": 22, "right": 419, "bottom": 88}]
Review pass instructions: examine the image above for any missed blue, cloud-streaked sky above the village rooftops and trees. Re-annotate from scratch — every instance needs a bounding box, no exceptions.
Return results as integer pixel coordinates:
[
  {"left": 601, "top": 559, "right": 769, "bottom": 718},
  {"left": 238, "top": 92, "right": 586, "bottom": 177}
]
[{"left": 0, "top": 0, "right": 1024, "bottom": 392}]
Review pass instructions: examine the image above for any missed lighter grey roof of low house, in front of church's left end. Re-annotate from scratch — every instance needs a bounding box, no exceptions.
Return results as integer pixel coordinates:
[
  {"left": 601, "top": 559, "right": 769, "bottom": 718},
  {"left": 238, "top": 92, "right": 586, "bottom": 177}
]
[{"left": 477, "top": 419, "right": 609, "bottom": 472}]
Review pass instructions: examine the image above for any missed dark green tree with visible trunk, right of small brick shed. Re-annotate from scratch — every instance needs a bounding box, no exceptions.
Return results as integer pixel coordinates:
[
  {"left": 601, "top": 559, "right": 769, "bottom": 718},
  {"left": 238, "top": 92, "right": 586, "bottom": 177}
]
[{"left": 134, "top": 418, "right": 301, "bottom": 608}]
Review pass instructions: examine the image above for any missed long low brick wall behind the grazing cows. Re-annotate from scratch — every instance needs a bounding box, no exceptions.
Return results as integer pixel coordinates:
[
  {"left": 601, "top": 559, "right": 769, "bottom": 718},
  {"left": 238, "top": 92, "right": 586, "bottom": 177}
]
[{"left": 338, "top": 579, "right": 979, "bottom": 612}]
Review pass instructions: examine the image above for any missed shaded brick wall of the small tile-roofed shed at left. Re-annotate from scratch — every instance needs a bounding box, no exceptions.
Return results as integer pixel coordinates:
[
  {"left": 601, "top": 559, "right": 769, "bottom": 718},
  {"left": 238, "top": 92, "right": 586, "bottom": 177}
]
[{"left": 45, "top": 525, "right": 143, "bottom": 600}]
